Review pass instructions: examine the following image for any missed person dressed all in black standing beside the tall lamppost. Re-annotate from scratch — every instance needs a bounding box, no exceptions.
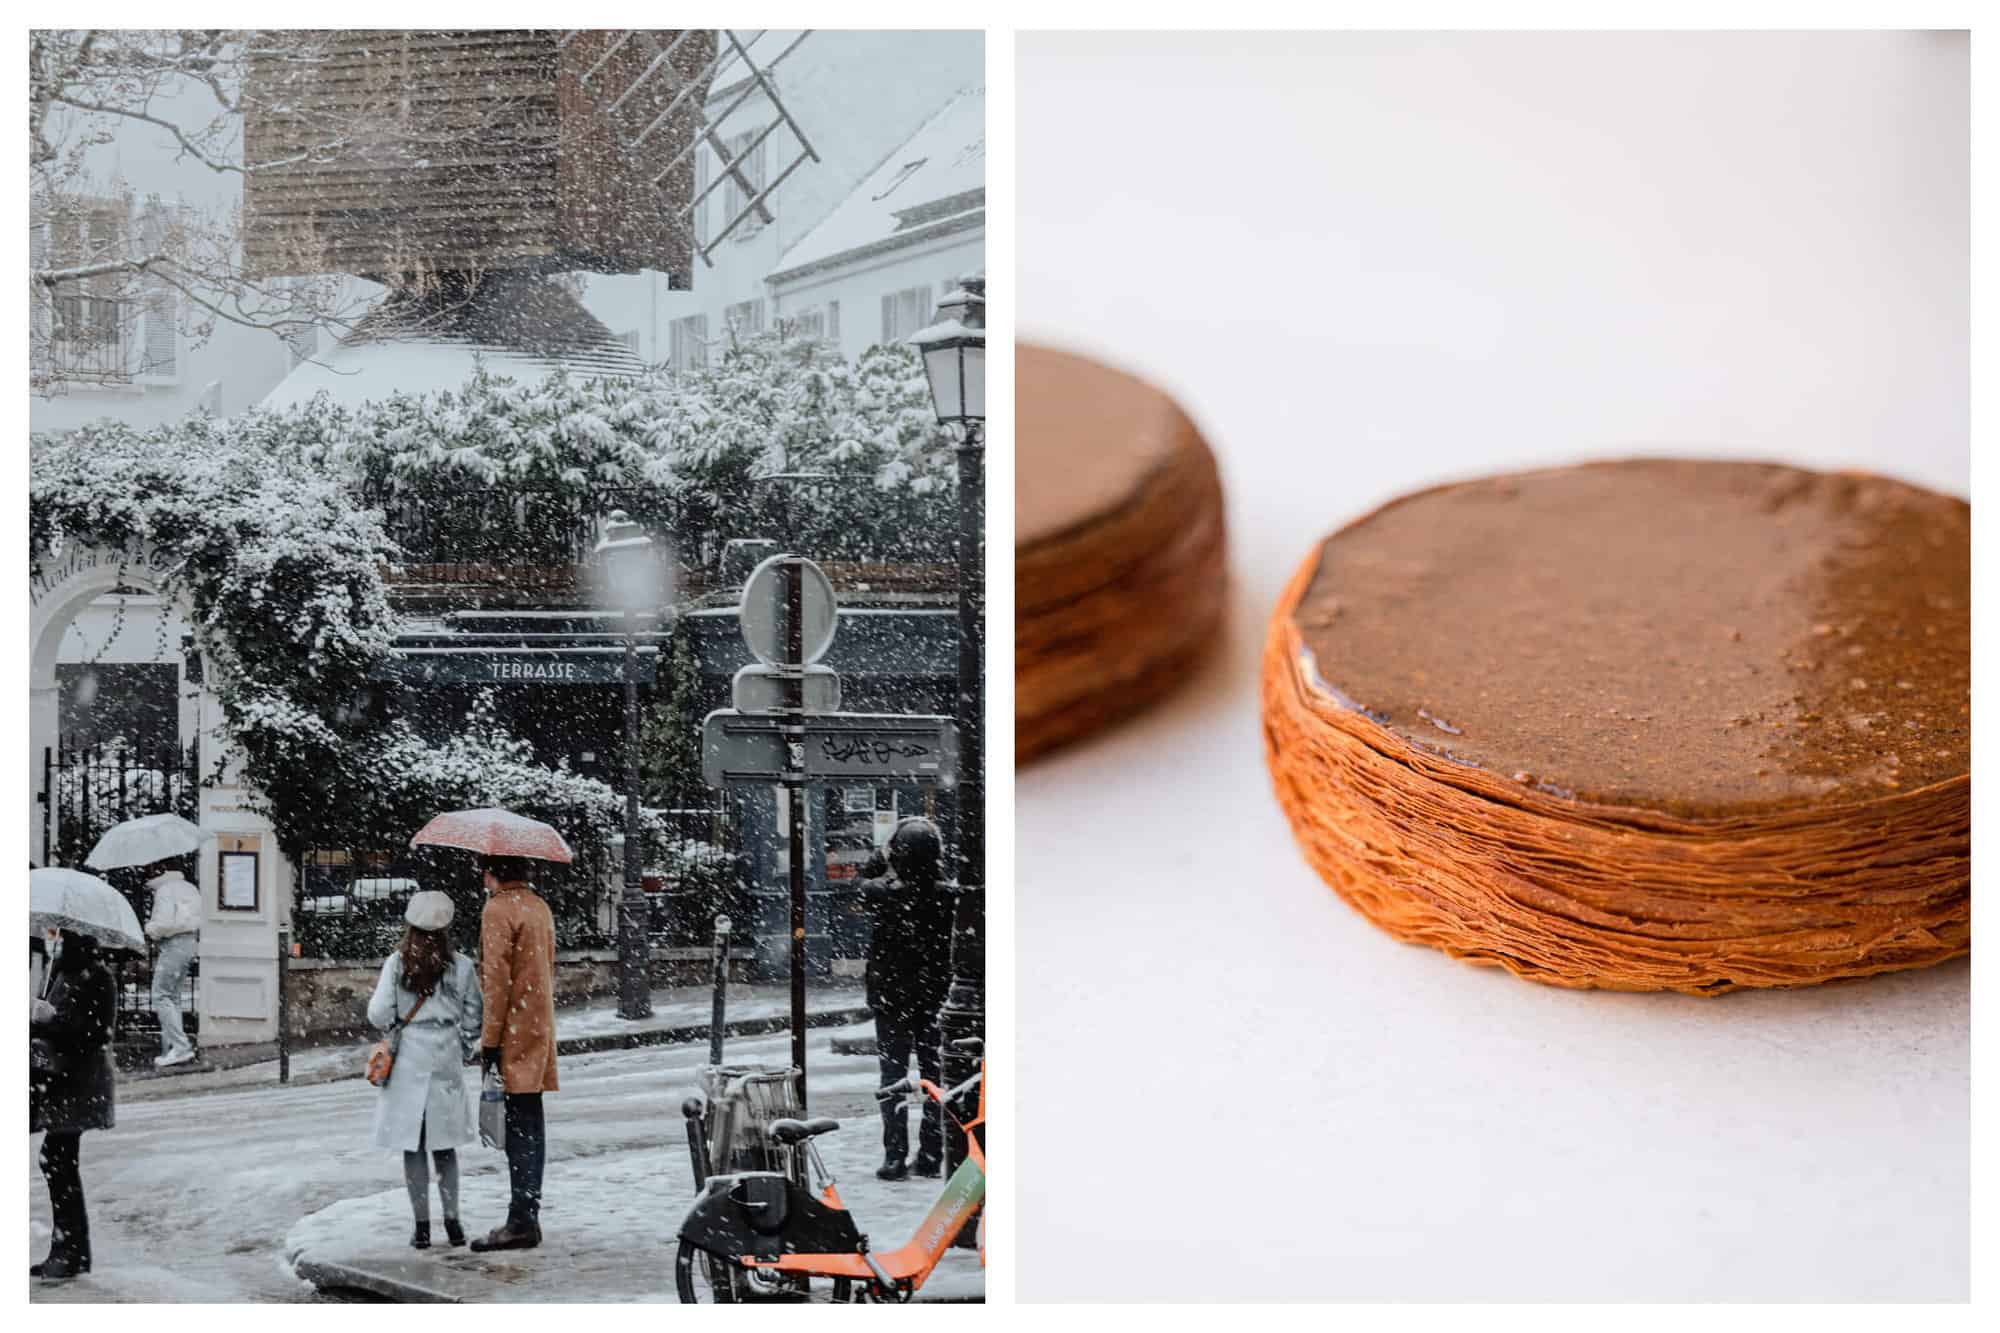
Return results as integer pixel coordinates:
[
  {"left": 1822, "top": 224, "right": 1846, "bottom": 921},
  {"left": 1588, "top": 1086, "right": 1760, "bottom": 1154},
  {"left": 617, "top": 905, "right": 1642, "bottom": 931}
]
[{"left": 860, "top": 819, "right": 956, "bottom": 1181}]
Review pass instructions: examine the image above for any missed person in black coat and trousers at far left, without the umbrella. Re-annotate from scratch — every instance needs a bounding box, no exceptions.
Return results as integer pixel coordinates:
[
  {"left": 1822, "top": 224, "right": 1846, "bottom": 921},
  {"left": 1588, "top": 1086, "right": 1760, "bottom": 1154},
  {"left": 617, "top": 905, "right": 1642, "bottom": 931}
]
[{"left": 28, "top": 931, "right": 118, "bottom": 1277}]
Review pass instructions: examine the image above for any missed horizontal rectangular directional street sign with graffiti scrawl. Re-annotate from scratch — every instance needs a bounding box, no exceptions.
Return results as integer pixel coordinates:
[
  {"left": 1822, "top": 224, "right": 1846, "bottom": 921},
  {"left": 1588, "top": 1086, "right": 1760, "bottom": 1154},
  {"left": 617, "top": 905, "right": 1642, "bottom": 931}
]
[{"left": 702, "top": 709, "right": 958, "bottom": 787}]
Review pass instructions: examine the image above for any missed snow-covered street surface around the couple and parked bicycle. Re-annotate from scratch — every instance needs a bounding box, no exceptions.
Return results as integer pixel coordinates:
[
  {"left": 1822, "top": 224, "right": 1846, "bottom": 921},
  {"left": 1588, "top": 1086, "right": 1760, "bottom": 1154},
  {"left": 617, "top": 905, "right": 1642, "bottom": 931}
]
[{"left": 28, "top": 1027, "right": 984, "bottom": 1301}]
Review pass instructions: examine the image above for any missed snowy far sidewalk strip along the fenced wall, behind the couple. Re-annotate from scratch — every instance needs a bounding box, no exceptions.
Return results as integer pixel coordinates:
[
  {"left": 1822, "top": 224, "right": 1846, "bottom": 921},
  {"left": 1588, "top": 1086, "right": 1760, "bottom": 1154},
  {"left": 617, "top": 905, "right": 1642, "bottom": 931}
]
[{"left": 118, "top": 983, "right": 868, "bottom": 1101}]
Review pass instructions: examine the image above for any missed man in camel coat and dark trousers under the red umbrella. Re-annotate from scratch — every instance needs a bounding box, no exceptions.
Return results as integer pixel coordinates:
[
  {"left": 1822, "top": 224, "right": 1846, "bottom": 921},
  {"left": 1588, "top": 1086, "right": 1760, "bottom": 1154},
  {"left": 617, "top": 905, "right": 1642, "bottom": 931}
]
[{"left": 472, "top": 857, "right": 556, "bottom": 1251}]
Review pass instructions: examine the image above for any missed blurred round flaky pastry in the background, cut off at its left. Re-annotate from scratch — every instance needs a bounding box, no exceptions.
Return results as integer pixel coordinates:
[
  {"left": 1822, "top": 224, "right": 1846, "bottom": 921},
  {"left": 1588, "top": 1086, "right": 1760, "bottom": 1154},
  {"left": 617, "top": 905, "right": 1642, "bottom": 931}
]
[{"left": 1014, "top": 344, "right": 1224, "bottom": 761}]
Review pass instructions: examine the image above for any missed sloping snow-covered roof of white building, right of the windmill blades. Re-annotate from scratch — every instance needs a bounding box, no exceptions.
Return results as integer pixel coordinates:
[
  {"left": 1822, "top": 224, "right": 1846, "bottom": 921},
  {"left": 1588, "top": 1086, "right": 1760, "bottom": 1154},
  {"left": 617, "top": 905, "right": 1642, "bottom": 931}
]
[{"left": 770, "top": 88, "right": 986, "bottom": 282}]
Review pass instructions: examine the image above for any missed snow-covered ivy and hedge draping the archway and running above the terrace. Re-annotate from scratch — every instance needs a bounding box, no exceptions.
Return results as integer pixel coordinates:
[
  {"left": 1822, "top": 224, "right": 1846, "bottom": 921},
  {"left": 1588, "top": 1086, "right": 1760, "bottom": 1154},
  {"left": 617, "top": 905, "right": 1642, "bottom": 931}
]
[{"left": 28, "top": 338, "right": 952, "bottom": 855}]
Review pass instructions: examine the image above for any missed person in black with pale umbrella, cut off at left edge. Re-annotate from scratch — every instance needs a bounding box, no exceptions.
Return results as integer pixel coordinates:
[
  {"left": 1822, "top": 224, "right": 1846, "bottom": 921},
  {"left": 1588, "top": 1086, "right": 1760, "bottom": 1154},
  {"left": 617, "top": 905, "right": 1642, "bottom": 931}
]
[{"left": 28, "top": 869, "right": 144, "bottom": 1279}]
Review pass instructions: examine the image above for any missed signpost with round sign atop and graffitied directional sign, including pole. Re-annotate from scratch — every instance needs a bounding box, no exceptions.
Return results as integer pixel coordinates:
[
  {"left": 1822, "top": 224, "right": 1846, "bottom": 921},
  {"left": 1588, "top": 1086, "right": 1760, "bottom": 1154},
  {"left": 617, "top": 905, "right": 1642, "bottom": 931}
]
[{"left": 702, "top": 554, "right": 958, "bottom": 1107}]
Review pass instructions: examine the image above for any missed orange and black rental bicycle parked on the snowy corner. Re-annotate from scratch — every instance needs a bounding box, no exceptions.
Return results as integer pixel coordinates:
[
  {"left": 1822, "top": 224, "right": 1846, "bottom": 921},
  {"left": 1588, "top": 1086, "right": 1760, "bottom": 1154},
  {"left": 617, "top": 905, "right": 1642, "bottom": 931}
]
[{"left": 674, "top": 1039, "right": 986, "bottom": 1305}]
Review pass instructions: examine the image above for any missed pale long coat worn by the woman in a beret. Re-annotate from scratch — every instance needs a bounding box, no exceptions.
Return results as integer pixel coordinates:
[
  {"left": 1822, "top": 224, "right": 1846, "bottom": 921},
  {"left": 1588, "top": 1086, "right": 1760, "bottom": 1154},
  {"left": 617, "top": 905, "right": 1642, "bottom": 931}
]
[{"left": 368, "top": 953, "right": 486, "bottom": 1153}]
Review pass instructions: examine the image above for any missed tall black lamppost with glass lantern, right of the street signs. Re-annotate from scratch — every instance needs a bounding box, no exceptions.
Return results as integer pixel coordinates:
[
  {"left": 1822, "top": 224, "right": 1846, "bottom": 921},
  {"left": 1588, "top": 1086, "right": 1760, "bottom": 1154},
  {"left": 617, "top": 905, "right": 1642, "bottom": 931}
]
[{"left": 910, "top": 274, "right": 986, "bottom": 1175}]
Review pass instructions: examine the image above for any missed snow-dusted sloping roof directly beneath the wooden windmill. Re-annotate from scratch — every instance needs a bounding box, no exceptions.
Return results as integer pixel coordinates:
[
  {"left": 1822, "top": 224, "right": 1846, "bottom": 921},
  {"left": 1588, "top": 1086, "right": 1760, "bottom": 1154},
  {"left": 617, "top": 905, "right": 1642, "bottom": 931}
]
[{"left": 262, "top": 274, "right": 646, "bottom": 410}]
